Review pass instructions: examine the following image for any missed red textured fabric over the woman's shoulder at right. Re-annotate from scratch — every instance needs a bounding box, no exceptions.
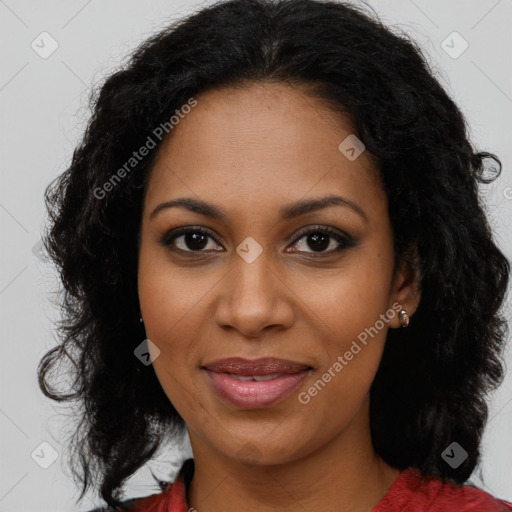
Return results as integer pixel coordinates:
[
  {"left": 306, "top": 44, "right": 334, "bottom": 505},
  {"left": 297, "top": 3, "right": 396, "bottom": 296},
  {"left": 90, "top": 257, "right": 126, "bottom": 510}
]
[{"left": 374, "top": 468, "right": 512, "bottom": 512}]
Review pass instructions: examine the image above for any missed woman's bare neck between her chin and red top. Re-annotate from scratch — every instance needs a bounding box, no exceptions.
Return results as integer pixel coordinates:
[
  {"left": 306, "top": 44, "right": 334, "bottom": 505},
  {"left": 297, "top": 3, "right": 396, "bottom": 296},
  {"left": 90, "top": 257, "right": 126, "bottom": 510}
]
[{"left": 187, "top": 407, "right": 399, "bottom": 512}]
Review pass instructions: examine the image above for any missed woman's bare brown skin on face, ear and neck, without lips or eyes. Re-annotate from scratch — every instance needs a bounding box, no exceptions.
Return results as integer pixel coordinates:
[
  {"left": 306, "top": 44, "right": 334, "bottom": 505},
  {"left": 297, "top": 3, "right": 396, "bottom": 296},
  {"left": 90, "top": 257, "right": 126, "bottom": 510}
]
[{"left": 138, "top": 83, "right": 420, "bottom": 512}]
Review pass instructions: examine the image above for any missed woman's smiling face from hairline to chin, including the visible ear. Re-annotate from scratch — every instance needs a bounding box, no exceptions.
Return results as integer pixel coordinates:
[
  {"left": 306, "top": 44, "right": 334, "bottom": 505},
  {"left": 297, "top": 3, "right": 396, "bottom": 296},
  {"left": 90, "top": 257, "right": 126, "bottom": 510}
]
[{"left": 138, "top": 84, "right": 417, "bottom": 464}]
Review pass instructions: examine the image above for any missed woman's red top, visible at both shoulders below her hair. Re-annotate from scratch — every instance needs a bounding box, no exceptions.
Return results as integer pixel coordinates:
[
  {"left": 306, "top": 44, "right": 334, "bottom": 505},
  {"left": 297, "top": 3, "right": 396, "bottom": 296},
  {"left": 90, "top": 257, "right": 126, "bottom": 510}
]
[{"left": 121, "top": 459, "right": 512, "bottom": 512}]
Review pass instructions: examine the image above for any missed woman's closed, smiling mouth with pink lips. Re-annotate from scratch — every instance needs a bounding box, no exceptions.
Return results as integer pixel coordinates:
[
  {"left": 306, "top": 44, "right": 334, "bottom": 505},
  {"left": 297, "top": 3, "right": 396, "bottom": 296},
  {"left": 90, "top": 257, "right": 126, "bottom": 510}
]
[{"left": 201, "top": 358, "right": 313, "bottom": 409}]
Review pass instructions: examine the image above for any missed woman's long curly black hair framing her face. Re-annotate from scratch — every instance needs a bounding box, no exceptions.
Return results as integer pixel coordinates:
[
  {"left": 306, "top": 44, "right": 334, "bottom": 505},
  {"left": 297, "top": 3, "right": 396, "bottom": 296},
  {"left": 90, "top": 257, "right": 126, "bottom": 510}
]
[{"left": 38, "top": 0, "right": 510, "bottom": 506}]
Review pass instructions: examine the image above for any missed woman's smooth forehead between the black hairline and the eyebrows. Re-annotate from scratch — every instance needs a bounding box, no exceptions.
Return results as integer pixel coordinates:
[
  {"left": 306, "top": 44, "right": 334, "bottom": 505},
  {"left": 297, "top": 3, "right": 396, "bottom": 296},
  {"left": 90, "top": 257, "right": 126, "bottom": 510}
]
[{"left": 143, "top": 83, "right": 385, "bottom": 220}]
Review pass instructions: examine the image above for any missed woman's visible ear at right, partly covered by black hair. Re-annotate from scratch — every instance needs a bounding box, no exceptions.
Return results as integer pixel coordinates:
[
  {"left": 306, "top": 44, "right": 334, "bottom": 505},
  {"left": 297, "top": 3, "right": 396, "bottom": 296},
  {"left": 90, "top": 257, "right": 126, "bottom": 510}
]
[{"left": 388, "top": 245, "right": 421, "bottom": 328}]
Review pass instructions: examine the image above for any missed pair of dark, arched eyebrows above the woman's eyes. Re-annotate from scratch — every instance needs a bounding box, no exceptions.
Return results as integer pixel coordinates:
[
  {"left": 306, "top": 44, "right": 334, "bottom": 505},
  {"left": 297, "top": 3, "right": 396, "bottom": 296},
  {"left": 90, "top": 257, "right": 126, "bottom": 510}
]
[{"left": 149, "top": 195, "right": 368, "bottom": 222}]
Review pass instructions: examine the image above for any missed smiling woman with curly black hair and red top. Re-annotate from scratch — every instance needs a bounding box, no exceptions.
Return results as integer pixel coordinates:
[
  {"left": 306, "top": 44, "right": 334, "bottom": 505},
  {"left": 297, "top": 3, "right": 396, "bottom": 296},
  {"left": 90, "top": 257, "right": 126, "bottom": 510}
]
[{"left": 39, "top": 0, "right": 512, "bottom": 512}]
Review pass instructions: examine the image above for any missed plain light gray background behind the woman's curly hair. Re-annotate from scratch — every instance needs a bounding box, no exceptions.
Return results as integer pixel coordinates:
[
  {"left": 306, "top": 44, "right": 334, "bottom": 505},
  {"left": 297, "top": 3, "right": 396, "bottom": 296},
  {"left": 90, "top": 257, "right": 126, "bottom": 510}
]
[{"left": 0, "top": 0, "right": 512, "bottom": 512}]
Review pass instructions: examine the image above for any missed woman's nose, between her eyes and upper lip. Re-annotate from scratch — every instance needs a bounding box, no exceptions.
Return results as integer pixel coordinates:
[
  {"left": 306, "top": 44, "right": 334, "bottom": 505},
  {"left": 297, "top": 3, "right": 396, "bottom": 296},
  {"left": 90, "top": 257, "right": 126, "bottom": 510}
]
[{"left": 215, "top": 253, "right": 294, "bottom": 338}]
